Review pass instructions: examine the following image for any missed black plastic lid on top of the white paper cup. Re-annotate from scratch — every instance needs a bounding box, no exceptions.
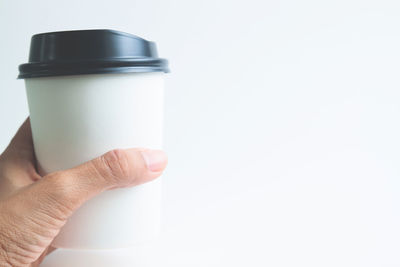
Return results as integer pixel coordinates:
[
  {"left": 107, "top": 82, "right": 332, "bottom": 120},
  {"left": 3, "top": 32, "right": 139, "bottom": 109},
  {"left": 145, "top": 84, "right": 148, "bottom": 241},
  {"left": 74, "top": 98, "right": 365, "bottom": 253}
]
[{"left": 18, "top": 30, "right": 169, "bottom": 79}]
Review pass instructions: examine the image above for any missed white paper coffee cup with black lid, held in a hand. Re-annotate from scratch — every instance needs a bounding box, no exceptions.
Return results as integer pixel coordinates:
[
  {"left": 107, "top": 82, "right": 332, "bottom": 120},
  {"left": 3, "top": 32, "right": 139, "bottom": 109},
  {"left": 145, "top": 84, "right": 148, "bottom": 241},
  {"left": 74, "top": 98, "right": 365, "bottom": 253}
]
[{"left": 18, "top": 30, "right": 168, "bottom": 249}]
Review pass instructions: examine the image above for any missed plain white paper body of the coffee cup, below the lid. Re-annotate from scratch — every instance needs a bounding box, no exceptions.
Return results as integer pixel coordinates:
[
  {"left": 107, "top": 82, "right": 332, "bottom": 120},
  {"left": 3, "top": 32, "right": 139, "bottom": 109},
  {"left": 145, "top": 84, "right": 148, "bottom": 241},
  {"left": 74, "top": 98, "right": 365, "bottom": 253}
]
[{"left": 25, "top": 72, "right": 164, "bottom": 249}]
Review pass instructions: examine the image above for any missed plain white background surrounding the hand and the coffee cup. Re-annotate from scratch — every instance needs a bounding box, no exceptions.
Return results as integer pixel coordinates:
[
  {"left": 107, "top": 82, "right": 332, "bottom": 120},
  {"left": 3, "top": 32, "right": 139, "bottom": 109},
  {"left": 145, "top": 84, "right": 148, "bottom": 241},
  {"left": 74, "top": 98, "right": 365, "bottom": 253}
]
[{"left": 0, "top": 0, "right": 400, "bottom": 267}]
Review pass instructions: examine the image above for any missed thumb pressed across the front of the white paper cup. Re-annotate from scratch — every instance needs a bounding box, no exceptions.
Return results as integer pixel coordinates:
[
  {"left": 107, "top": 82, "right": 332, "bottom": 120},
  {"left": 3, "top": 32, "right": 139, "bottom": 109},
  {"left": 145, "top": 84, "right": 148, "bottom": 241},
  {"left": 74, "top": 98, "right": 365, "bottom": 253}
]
[{"left": 21, "top": 149, "right": 167, "bottom": 219}]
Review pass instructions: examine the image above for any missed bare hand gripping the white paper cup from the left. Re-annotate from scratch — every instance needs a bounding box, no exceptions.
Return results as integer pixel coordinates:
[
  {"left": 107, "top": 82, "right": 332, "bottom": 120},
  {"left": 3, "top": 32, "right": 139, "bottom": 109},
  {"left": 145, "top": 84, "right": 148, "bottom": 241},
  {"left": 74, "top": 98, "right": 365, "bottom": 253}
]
[{"left": 0, "top": 119, "right": 167, "bottom": 267}]
